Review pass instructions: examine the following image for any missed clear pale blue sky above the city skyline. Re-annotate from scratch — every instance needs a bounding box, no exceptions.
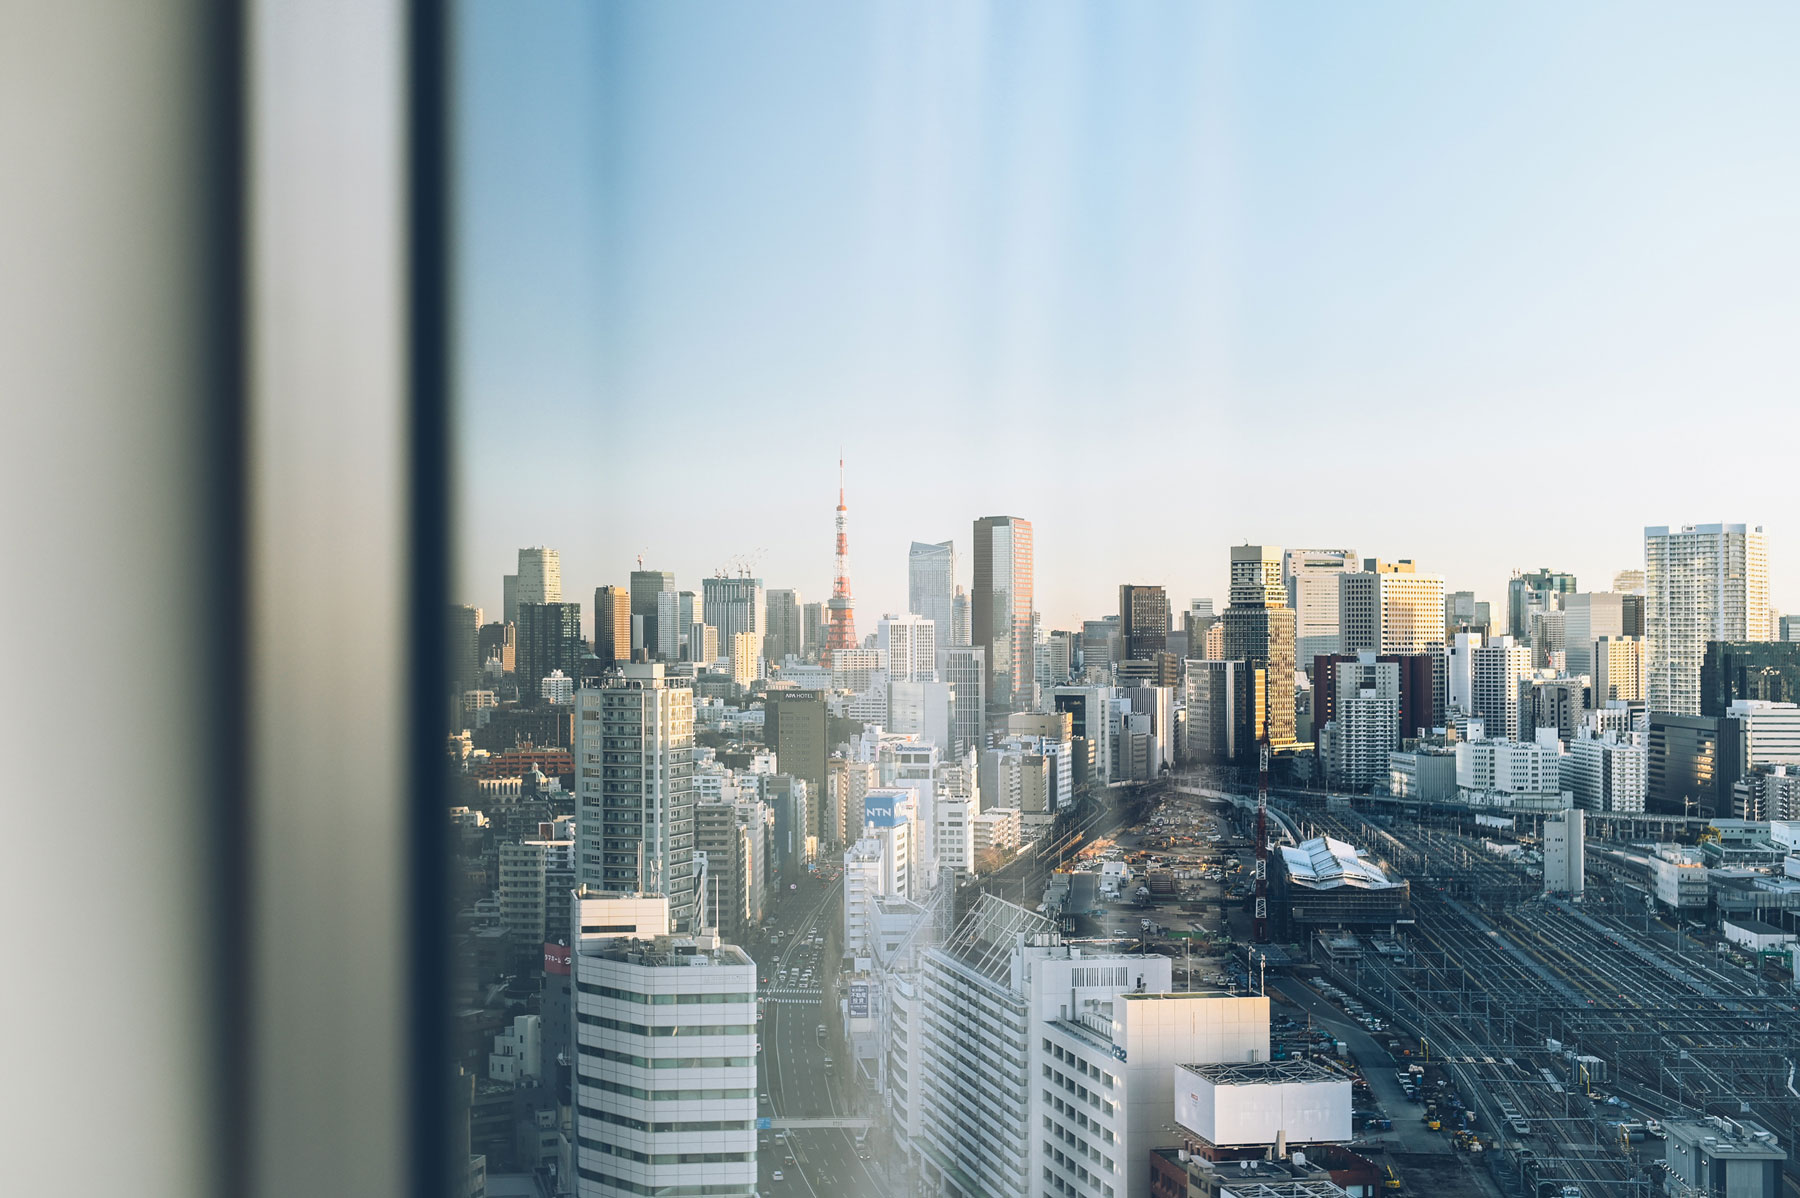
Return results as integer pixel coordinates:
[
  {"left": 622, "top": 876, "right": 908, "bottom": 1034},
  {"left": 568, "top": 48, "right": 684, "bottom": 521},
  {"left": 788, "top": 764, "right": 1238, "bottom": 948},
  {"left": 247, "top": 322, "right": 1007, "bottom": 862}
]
[{"left": 455, "top": 0, "right": 1800, "bottom": 631}]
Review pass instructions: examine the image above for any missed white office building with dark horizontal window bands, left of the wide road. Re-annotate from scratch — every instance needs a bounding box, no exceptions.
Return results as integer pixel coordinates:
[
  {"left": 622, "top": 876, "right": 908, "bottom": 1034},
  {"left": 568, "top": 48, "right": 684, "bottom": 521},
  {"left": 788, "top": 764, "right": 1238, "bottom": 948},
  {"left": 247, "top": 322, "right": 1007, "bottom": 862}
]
[{"left": 572, "top": 892, "right": 756, "bottom": 1198}]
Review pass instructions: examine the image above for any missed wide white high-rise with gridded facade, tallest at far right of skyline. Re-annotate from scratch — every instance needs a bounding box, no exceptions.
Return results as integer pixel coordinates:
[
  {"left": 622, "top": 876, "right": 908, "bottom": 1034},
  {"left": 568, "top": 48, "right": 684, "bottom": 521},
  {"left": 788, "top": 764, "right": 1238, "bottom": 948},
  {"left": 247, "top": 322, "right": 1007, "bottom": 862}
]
[{"left": 1643, "top": 523, "right": 1769, "bottom": 716}]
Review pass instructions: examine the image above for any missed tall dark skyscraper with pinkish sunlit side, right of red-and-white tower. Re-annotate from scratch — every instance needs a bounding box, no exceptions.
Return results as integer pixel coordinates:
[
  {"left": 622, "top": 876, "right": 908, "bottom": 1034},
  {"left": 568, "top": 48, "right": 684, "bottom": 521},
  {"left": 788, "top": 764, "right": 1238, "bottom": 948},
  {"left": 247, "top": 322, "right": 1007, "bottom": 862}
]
[{"left": 968, "top": 516, "right": 1037, "bottom": 712}]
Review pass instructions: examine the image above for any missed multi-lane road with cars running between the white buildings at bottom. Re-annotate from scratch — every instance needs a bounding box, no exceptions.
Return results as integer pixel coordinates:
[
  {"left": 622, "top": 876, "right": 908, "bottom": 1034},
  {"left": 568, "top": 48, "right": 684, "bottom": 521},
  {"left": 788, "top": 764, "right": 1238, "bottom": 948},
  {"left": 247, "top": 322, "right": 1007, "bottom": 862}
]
[{"left": 751, "top": 878, "right": 886, "bottom": 1198}]
